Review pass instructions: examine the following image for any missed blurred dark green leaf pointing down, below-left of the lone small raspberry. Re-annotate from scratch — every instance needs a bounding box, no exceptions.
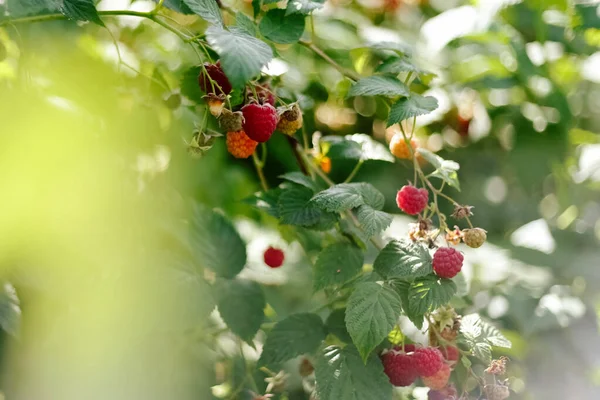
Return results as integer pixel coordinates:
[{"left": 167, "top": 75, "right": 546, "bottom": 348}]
[{"left": 217, "top": 280, "right": 266, "bottom": 343}]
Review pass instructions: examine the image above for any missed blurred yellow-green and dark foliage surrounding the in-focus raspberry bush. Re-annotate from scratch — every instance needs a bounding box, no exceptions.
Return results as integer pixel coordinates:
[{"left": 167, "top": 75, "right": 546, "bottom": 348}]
[{"left": 0, "top": 0, "right": 600, "bottom": 399}]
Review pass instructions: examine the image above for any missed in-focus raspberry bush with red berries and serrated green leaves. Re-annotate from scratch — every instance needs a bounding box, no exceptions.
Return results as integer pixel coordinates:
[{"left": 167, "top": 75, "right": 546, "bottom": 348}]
[{"left": 0, "top": 0, "right": 600, "bottom": 400}]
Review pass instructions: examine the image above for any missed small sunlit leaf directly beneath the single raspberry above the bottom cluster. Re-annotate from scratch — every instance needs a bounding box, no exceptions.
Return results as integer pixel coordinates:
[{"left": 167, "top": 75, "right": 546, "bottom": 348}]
[{"left": 408, "top": 276, "right": 456, "bottom": 315}]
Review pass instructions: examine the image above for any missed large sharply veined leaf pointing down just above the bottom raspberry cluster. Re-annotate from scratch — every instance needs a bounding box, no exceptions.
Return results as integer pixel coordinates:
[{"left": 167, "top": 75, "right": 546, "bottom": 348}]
[{"left": 346, "top": 282, "right": 402, "bottom": 361}]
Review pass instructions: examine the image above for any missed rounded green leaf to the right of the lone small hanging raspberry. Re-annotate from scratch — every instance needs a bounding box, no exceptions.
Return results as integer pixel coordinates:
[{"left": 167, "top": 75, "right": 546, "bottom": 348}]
[{"left": 313, "top": 243, "right": 364, "bottom": 291}]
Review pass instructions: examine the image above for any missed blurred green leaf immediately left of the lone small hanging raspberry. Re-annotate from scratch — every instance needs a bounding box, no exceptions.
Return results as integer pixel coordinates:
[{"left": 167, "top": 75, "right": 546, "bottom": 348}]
[{"left": 190, "top": 206, "right": 246, "bottom": 278}]
